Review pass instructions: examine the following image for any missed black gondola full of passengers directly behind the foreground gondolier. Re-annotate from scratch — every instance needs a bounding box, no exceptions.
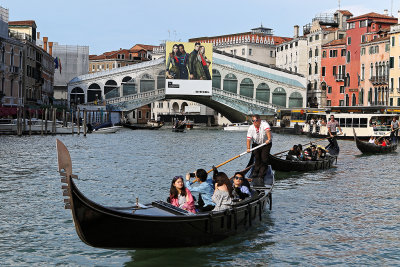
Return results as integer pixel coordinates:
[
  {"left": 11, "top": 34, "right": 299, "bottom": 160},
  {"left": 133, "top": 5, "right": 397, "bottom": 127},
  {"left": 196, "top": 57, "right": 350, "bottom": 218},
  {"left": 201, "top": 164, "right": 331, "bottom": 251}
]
[{"left": 269, "top": 137, "right": 339, "bottom": 172}]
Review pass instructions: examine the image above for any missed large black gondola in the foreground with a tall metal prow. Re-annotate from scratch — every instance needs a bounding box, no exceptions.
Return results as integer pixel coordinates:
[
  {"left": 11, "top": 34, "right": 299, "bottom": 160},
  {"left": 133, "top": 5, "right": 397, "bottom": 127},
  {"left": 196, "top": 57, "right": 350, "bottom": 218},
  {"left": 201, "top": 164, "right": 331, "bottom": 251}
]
[{"left": 57, "top": 140, "right": 274, "bottom": 249}]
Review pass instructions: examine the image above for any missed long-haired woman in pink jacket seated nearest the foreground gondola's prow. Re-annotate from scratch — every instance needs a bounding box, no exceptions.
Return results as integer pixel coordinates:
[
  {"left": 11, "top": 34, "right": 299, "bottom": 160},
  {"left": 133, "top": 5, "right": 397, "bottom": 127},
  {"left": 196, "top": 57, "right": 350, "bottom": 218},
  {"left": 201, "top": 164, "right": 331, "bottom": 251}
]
[{"left": 168, "top": 176, "right": 196, "bottom": 213}]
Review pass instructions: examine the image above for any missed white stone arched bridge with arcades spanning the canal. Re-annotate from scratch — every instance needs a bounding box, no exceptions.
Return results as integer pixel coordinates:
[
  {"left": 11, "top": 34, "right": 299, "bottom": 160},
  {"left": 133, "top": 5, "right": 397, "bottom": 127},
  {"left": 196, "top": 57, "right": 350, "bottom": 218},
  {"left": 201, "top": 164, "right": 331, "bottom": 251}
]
[{"left": 68, "top": 51, "right": 306, "bottom": 122}]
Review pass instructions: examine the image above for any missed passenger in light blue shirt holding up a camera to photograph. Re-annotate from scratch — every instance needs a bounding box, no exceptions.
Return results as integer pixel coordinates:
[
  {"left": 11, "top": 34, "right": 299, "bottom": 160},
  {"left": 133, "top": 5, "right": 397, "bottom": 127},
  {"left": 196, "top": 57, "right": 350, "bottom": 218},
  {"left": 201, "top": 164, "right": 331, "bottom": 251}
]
[{"left": 185, "top": 169, "right": 215, "bottom": 212}]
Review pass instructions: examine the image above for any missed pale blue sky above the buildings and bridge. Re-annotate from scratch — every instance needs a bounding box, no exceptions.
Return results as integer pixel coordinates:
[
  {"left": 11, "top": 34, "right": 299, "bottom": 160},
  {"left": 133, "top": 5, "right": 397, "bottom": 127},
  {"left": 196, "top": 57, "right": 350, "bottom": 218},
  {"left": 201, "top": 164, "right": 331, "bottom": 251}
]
[{"left": 0, "top": 0, "right": 400, "bottom": 55}]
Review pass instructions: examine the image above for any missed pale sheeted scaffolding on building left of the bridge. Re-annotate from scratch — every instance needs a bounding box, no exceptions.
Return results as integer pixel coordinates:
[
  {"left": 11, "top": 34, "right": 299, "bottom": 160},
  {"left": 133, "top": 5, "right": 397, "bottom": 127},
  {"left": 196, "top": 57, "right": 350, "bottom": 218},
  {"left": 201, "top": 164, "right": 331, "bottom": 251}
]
[{"left": 53, "top": 44, "right": 89, "bottom": 87}]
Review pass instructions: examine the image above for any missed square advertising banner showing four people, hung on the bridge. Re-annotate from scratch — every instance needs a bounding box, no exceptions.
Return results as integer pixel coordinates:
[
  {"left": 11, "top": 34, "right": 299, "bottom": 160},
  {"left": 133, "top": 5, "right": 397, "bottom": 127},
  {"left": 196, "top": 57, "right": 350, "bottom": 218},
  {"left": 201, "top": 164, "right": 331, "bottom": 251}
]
[{"left": 165, "top": 42, "right": 212, "bottom": 96}]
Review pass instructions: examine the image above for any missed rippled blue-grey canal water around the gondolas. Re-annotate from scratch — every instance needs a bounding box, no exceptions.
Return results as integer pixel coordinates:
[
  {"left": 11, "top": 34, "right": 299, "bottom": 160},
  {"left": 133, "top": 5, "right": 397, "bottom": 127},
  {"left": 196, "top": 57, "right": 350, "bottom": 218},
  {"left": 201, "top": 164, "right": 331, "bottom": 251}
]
[{"left": 0, "top": 129, "right": 400, "bottom": 266}]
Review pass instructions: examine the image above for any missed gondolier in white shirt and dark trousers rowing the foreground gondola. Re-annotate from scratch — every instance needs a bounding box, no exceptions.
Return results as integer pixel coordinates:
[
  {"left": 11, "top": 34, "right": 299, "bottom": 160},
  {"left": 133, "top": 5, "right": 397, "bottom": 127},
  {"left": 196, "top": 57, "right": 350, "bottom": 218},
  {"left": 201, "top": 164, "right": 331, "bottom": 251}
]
[{"left": 247, "top": 115, "right": 272, "bottom": 185}]
